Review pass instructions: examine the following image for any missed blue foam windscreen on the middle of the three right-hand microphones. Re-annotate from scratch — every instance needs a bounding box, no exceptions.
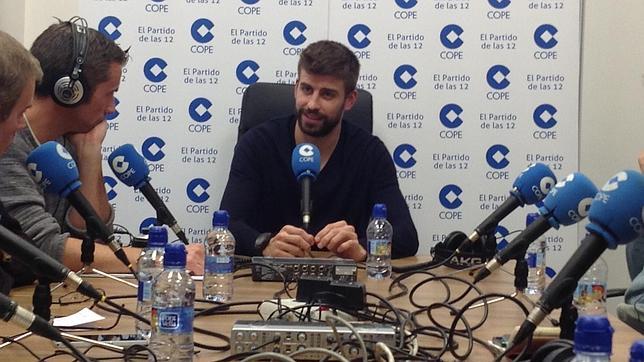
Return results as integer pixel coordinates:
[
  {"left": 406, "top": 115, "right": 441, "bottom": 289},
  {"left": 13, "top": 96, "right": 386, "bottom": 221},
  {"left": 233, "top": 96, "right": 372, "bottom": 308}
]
[{"left": 539, "top": 172, "right": 598, "bottom": 229}]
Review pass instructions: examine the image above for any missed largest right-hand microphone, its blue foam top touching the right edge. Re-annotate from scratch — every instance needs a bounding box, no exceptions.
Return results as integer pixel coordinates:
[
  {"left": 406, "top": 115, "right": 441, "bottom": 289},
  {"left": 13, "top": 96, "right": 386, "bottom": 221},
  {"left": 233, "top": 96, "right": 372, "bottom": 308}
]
[{"left": 512, "top": 170, "right": 644, "bottom": 345}]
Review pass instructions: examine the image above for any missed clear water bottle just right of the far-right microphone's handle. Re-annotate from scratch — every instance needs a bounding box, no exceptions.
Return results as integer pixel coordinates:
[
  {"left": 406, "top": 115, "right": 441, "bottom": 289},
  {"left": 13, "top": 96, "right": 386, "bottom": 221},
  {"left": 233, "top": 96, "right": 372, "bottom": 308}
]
[{"left": 573, "top": 258, "right": 608, "bottom": 315}]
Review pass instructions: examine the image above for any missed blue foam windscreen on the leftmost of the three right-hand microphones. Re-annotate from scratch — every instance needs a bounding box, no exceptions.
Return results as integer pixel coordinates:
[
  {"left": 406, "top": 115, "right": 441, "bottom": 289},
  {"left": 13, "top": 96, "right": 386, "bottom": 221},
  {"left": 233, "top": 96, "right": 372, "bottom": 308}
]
[{"left": 512, "top": 163, "right": 557, "bottom": 206}]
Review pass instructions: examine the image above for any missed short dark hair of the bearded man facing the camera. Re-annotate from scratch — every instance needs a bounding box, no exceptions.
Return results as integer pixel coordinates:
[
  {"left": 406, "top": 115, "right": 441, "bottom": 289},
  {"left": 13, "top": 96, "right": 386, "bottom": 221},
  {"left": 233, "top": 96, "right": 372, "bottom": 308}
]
[{"left": 297, "top": 40, "right": 360, "bottom": 94}]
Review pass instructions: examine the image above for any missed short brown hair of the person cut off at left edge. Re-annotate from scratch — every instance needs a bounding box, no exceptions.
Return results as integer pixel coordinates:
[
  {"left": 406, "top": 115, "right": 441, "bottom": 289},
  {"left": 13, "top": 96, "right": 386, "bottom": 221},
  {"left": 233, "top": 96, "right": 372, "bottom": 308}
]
[{"left": 0, "top": 31, "right": 42, "bottom": 122}]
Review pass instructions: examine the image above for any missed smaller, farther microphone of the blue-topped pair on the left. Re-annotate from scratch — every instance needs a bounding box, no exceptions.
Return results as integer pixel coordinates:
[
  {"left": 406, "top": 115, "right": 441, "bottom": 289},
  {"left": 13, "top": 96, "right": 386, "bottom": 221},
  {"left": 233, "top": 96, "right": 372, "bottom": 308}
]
[{"left": 108, "top": 143, "right": 188, "bottom": 245}]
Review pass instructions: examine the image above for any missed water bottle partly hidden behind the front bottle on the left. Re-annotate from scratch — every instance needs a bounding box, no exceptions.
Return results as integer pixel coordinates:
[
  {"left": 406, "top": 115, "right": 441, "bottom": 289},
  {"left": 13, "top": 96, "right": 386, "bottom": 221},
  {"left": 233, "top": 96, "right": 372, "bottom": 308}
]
[{"left": 134, "top": 226, "right": 168, "bottom": 339}]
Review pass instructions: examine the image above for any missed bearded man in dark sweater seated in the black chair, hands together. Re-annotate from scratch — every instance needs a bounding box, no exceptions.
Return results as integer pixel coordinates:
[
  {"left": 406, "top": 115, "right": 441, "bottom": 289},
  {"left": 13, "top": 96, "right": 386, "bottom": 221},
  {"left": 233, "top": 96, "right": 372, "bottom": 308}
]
[{"left": 220, "top": 41, "right": 418, "bottom": 261}]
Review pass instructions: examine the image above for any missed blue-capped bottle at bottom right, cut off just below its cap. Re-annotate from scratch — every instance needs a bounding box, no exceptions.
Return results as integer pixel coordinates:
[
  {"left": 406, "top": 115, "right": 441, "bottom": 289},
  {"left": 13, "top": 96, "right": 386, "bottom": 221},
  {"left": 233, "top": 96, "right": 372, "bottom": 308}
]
[{"left": 573, "top": 315, "right": 613, "bottom": 362}]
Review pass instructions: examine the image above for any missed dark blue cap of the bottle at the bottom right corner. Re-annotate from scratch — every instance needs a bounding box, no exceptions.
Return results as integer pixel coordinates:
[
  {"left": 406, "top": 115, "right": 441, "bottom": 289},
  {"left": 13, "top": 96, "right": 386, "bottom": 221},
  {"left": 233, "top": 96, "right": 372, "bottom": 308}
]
[{"left": 575, "top": 316, "right": 614, "bottom": 354}]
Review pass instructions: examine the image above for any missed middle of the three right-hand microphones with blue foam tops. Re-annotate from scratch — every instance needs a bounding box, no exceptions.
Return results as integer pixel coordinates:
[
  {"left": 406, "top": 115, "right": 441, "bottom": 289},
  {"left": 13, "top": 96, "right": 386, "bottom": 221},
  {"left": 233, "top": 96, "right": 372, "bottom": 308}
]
[{"left": 474, "top": 172, "right": 597, "bottom": 283}]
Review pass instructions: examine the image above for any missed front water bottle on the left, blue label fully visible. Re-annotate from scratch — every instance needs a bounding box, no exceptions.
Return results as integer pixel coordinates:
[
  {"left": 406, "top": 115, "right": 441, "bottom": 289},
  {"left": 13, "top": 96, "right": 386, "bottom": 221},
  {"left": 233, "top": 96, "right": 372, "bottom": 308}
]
[{"left": 148, "top": 242, "right": 195, "bottom": 362}]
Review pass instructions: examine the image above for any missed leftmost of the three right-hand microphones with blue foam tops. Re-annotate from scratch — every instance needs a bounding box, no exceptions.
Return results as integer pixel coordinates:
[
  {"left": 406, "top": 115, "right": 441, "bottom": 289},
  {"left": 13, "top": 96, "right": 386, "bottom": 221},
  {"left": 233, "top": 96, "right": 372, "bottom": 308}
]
[{"left": 456, "top": 163, "right": 557, "bottom": 253}]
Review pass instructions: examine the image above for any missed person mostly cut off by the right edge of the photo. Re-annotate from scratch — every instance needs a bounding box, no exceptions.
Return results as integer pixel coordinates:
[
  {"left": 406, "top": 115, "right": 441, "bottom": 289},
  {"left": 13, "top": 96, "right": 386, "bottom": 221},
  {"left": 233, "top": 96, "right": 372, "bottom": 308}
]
[{"left": 617, "top": 150, "right": 644, "bottom": 334}]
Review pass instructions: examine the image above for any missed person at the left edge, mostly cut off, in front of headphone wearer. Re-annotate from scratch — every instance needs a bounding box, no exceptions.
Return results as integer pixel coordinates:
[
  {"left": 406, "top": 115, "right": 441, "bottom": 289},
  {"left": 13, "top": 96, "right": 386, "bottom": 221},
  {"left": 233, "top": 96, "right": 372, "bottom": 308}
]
[{"left": 0, "top": 31, "right": 42, "bottom": 294}]
